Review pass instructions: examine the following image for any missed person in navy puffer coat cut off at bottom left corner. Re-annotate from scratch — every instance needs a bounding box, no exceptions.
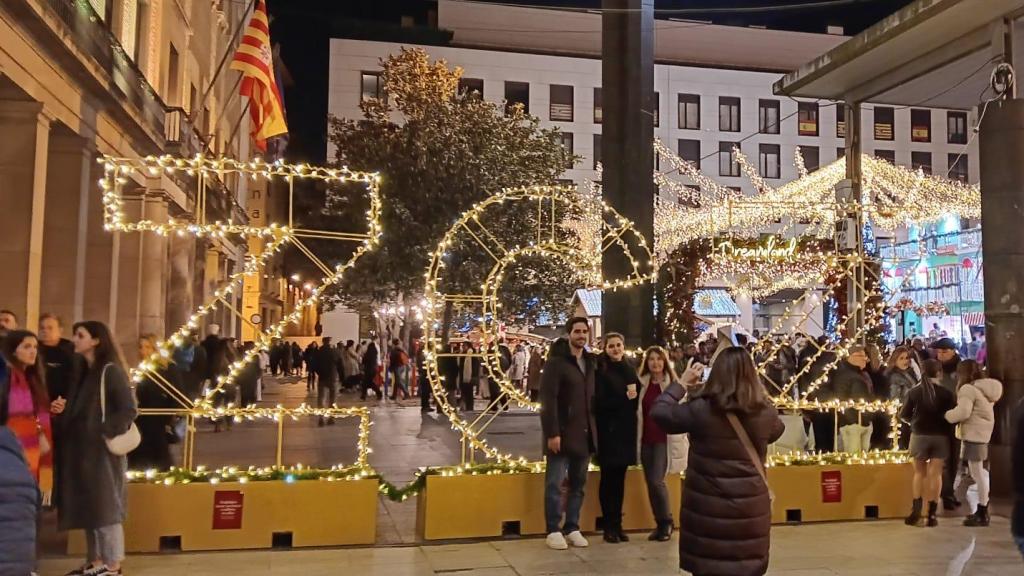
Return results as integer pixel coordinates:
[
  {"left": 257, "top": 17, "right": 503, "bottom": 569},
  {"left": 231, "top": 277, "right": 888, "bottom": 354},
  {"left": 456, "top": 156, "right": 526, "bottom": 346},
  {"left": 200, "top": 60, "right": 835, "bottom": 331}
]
[{"left": 0, "top": 375, "right": 39, "bottom": 575}]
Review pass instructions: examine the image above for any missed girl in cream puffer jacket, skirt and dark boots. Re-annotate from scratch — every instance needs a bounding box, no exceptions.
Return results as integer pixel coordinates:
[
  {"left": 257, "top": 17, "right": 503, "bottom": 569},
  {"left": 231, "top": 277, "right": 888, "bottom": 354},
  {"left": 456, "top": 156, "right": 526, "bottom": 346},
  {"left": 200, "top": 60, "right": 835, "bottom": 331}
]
[{"left": 946, "top": 360, "right": 1002, "bottom": 526}]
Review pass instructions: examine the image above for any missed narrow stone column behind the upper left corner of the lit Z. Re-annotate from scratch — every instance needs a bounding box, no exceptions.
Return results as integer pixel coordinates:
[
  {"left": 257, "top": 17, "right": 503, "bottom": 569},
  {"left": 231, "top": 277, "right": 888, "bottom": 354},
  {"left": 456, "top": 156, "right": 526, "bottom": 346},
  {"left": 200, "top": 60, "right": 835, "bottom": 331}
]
[{"left": 138, "top": 195, "right": 170, "bottom": 338}]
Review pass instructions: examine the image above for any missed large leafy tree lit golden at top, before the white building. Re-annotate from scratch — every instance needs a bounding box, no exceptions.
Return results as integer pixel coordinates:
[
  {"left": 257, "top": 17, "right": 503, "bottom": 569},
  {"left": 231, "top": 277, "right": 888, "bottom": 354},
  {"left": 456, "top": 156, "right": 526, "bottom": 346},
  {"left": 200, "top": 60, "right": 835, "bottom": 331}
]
[{"left": 319, "top": 48, "right": 578, "bottom": 336}]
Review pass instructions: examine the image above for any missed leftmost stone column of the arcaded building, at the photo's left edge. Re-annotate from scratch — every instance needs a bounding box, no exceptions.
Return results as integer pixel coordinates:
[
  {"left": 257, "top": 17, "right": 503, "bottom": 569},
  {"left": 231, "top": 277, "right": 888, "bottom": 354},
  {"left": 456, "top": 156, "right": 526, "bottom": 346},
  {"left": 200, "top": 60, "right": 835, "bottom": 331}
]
[{"left": 0, "top": 100, "right": 50, "bottom": 329}]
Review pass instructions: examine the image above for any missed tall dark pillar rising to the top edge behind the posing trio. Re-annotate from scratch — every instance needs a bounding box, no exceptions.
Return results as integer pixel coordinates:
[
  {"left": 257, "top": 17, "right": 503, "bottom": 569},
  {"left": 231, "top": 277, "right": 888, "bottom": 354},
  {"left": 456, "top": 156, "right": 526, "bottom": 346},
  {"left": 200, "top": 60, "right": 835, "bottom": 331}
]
[{"left": 601, "top": 0, "right": 655, "bottom": 346}]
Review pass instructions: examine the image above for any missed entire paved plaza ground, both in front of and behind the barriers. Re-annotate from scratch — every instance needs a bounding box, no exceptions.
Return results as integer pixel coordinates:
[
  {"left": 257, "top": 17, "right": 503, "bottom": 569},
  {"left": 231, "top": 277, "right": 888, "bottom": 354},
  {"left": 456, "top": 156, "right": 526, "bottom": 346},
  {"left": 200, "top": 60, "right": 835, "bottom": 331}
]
[{"left": 41, "top": 378, "right": 1024, "bottom": 576}]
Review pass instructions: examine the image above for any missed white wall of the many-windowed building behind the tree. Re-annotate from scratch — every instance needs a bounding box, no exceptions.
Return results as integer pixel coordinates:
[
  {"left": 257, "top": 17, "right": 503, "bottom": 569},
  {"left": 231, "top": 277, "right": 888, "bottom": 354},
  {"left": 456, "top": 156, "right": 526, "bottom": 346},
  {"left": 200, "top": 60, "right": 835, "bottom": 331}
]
[{"left": 328, "top": 37, "right": 979, "bottom": 193}]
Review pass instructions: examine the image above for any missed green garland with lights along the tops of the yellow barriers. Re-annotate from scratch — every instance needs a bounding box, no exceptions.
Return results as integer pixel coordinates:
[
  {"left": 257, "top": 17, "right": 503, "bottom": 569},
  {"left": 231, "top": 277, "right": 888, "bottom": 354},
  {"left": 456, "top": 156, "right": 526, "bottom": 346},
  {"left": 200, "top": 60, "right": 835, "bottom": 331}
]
[{"left": 127, "top": 450, "right": 909, "bottom": 502}]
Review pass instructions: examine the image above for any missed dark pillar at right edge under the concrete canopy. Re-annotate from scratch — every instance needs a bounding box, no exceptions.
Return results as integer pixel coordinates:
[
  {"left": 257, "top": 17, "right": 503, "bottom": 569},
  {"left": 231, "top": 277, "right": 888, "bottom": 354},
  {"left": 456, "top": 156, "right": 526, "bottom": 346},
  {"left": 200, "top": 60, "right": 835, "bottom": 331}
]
[{"left": 979, "top": 99, "right": 1024, "bottom": 495}]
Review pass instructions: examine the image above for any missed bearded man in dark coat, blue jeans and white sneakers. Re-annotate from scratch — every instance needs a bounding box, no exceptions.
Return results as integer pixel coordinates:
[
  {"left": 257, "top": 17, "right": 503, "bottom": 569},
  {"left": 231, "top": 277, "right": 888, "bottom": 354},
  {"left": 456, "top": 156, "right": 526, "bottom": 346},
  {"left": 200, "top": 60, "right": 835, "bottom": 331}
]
[{"left": 541, "top": 317, "right": 597, "bottom": 550}]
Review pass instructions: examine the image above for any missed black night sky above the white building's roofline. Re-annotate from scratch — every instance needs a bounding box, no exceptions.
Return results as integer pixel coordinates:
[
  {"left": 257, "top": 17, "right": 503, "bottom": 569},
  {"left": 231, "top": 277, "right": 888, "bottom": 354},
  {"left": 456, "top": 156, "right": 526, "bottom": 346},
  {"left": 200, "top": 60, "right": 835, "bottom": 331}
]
[{"left": 267, "top": 0, "right": 910, "bottom": 164}]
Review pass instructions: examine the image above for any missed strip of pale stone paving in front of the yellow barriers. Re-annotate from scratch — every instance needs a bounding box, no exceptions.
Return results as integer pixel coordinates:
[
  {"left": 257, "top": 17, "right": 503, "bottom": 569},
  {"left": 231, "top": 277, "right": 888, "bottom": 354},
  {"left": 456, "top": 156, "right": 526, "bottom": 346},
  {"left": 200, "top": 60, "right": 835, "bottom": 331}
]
[{"left": 40, "top": 518, "right": 1024, "bottom": 576}]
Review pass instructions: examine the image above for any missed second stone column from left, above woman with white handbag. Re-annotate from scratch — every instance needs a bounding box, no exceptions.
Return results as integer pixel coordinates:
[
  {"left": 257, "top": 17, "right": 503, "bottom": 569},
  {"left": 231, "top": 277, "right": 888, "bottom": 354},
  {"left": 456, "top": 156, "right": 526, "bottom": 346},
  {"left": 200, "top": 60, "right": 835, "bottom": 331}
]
[{"left": 39, "top": 126, "right": 94, "bottom": 323}]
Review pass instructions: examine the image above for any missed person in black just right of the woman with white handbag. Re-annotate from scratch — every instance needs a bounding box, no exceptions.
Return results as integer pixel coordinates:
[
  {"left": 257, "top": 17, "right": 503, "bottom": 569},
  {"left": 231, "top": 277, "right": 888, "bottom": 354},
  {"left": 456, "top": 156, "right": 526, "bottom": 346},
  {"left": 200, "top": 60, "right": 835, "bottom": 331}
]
[{"left": 131, "top": 334, "right": 181, "bottom": 470}]
